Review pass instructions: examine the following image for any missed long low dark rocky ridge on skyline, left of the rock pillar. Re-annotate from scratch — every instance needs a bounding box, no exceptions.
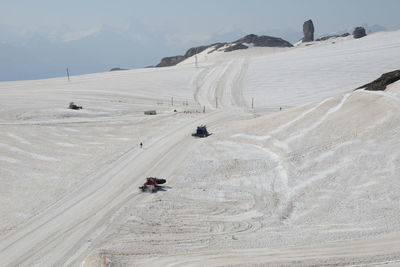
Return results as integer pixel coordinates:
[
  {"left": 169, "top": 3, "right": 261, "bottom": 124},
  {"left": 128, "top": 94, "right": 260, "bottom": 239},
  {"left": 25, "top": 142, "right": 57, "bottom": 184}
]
[{"left": 156, "top": 34, "right": 293, "bottom": 67}]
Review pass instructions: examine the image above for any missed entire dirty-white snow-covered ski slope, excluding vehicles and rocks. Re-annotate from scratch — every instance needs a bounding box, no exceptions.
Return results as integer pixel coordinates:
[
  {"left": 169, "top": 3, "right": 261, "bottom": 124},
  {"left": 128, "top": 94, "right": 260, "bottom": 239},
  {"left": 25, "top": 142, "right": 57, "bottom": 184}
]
[{"left": 0, "top": 31, "right": 400, "bottom": 266}]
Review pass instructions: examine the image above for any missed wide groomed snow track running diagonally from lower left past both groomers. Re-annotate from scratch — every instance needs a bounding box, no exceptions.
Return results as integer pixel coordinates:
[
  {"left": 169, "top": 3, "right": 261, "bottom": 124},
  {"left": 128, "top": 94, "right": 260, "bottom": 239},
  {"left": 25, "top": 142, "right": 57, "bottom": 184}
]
[{"left": 0, "top": 112, "right": 234, "bottom": 266}]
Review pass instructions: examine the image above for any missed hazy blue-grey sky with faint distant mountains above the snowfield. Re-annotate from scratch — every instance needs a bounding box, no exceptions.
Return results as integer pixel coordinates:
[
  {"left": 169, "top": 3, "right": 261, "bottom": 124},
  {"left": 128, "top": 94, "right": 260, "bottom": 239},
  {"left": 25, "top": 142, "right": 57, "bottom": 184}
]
[{"left": 0, "top": 0, "right": 400, "bottom": 80}]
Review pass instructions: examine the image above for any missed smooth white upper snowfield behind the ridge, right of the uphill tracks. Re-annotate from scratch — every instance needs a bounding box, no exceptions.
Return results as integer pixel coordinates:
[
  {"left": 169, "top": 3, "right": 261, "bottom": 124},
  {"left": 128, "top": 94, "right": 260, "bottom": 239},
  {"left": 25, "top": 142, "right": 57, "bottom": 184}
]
[{"left": 180, "top": 31, "right": 400, "bottom": 111}]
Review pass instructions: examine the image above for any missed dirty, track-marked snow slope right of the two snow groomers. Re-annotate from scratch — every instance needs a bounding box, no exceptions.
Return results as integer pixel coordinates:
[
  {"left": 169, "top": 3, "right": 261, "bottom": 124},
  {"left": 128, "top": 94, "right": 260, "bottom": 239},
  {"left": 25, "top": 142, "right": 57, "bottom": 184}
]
[{"left": 88, "top": 83, "right": 400, "bottom": 266}]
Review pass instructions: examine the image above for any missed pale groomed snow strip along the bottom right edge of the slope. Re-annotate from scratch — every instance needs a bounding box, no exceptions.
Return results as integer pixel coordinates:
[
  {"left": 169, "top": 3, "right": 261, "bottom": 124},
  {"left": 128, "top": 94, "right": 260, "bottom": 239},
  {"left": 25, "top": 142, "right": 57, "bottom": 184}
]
[{"left": 129, "top": 233, "right": 400, "bottom": 267}]
